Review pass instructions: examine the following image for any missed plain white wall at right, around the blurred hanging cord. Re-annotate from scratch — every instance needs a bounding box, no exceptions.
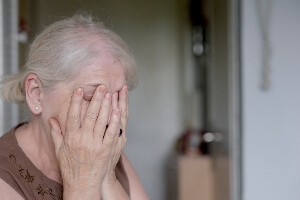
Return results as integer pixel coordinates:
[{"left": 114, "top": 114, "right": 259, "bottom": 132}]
[{"left": 242, "top": 0, "right": 300, "bottom": 200}]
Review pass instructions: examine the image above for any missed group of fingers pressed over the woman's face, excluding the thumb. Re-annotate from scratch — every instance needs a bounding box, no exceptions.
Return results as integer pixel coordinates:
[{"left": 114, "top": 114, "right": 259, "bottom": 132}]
[{"left": 66, "top": 85, "right": 128, "bottom": 144}]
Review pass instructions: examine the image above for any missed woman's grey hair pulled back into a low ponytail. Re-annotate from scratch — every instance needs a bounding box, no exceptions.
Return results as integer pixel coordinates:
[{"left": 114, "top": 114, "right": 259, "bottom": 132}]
[{"left": 1, "top": 14, "right": 136, "bottom": 103}]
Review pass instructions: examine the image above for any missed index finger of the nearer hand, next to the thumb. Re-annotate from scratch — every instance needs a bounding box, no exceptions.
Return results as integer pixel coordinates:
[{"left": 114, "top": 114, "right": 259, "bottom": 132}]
[{"left": 66, "top": 88, "right": 83, "bottom": 133}]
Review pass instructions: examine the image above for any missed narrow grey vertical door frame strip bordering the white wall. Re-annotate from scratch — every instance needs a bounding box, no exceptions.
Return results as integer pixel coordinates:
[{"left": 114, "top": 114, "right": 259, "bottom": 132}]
[{"left": 228, "top": 0, "right": 243, "bottom": 200}]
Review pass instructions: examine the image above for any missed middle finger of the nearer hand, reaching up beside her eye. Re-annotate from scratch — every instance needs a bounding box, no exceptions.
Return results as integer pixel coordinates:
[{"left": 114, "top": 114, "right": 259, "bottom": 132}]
[{"left": 82, "top": 85, "right": 106, "bottom": 132}]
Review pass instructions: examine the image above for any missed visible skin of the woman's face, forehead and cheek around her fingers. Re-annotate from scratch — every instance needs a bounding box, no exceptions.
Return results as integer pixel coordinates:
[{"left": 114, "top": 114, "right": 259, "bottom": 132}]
[{"left": 42, "top": 49, "right": 126, "bottom": 133}]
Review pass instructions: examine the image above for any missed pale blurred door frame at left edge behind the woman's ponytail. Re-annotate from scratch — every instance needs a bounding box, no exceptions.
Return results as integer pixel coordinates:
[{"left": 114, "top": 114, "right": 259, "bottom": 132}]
[{"left": 0, "top": 0, "right": 19, "bottom": 136}]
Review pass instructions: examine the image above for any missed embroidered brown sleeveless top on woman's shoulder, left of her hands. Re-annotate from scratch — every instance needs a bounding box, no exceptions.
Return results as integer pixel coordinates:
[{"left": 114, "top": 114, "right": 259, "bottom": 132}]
[{"left": 0, "top": 125, "right": 63, "bottom": 200}]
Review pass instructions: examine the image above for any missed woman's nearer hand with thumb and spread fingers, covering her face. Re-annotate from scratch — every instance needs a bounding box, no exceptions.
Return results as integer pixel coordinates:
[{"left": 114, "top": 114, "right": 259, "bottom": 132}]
[{"left": 49, "top": 86, "right": 121, "bottom": 199}]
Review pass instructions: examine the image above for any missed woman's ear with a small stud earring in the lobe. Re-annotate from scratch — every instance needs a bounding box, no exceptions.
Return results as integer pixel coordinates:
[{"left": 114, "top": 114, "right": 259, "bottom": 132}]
[{"left": 25, "top": 74, "right": 43, "bottom": 115}]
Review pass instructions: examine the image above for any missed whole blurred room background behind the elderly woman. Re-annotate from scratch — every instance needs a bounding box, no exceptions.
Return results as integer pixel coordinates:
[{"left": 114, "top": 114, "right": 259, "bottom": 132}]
[{"left": 0, "top": 0, "right": 300, "bottom": 200}]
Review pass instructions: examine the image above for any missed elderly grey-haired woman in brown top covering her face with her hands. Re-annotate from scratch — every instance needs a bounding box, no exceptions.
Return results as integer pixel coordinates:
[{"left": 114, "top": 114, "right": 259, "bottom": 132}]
[{"left": 0, "top": 15, "right": 148, "bottom": 200}]
